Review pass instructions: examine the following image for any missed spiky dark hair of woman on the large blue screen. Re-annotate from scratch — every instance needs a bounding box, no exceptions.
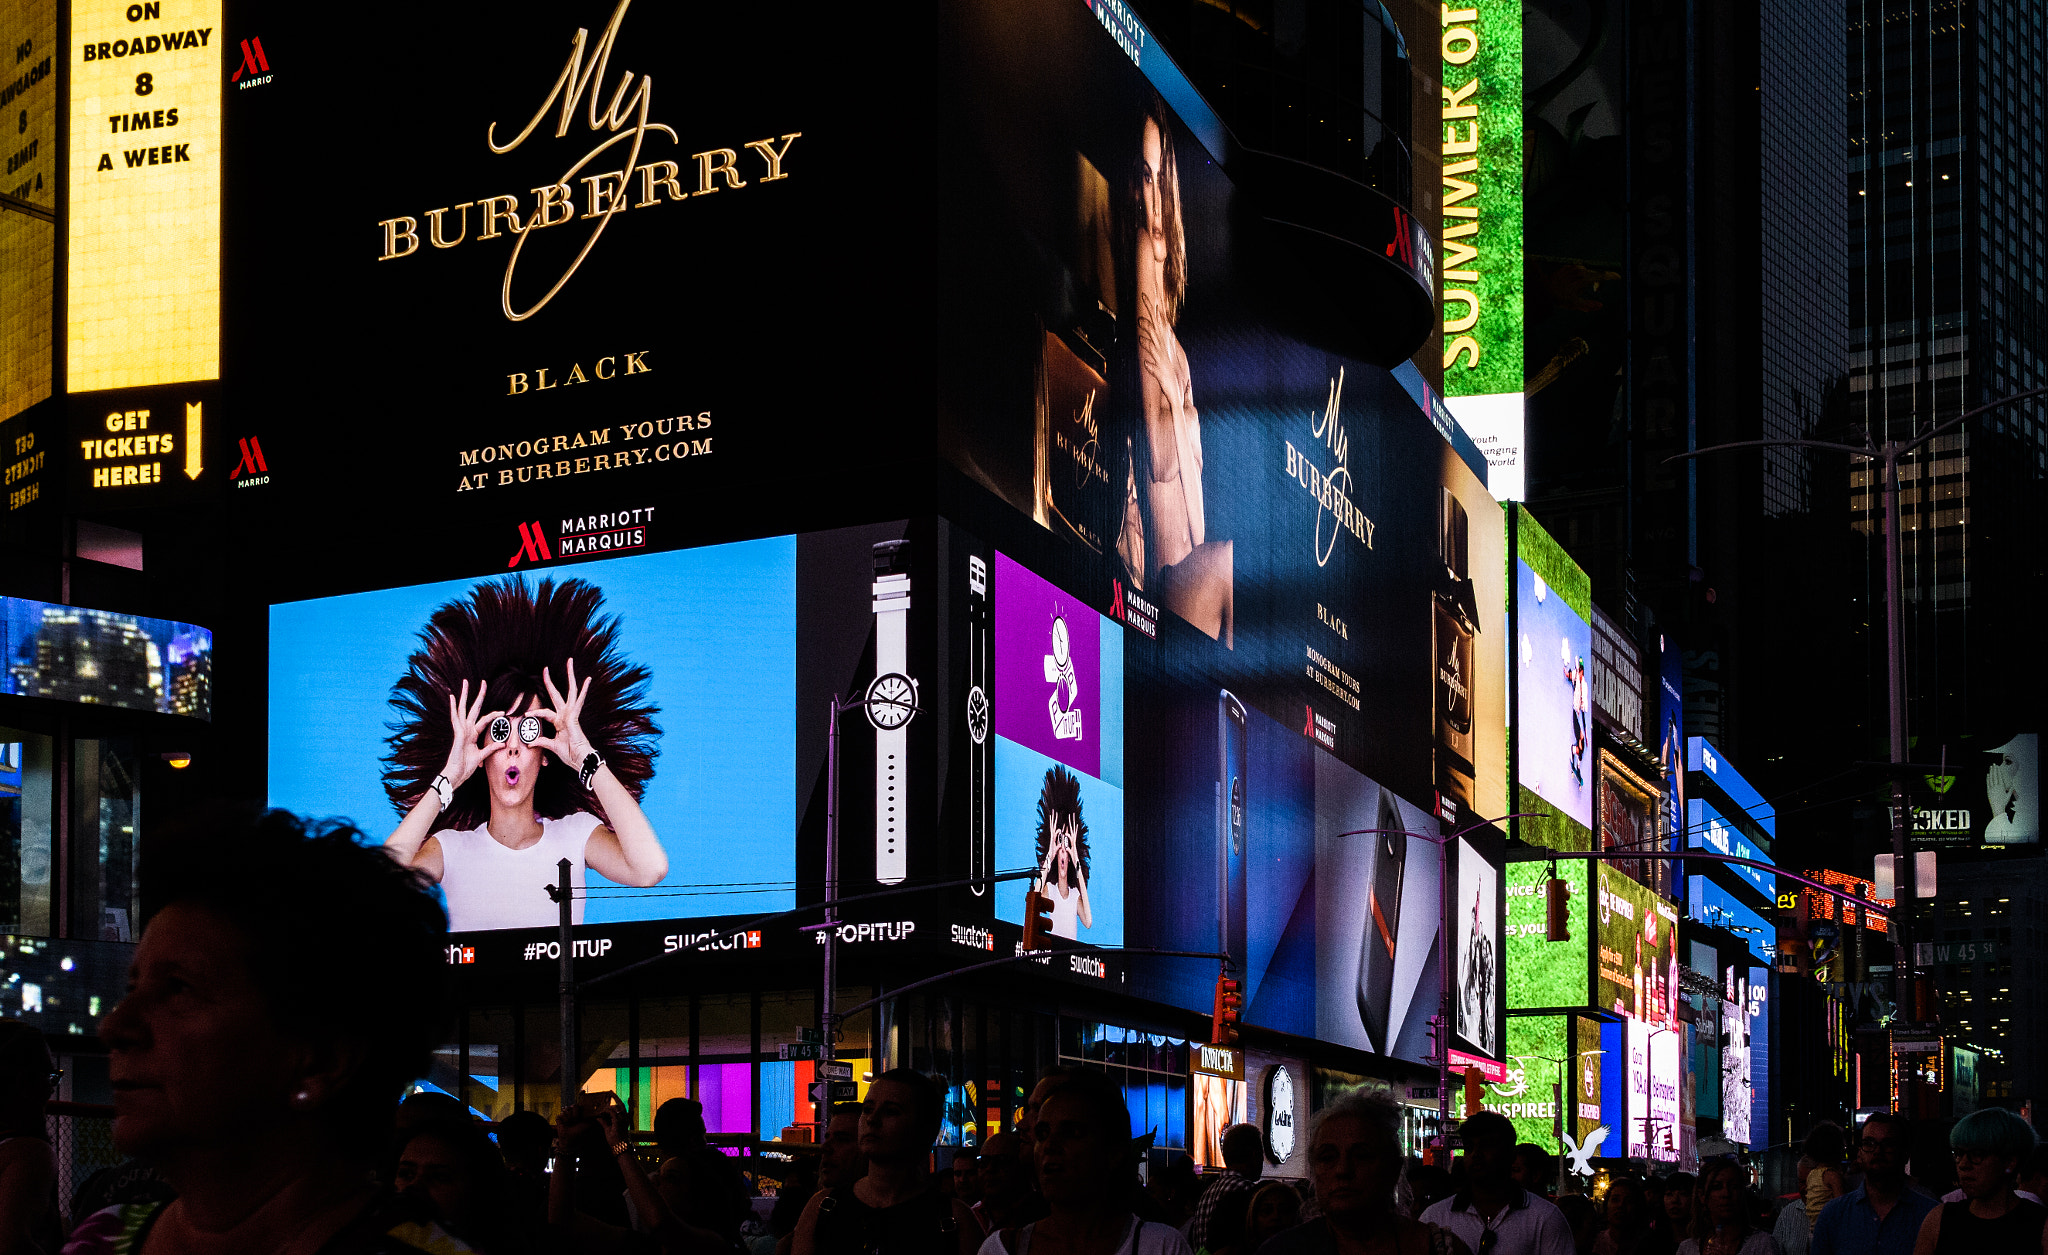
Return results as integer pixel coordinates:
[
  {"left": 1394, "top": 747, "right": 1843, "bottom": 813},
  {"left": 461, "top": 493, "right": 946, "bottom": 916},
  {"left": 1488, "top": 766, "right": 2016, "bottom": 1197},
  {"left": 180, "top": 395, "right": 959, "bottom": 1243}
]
[{"left": 383, "top": 575, "right": 662, "bottom": 831}]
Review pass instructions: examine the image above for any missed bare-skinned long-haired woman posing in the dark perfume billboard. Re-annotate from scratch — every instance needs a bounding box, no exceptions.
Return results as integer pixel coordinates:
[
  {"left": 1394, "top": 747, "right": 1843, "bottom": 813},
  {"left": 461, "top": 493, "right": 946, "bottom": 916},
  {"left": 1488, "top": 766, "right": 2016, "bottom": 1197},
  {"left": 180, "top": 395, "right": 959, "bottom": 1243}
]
[{"left": 1116, "top": 98, "right": 1235, "bottom": 649}]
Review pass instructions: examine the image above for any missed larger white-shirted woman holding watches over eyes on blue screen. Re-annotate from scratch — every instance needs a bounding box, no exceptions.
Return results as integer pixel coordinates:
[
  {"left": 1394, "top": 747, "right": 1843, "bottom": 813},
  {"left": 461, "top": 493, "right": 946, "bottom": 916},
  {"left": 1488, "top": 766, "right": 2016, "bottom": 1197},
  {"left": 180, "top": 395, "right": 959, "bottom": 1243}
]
[{"left": 383, "top": 577, "right": 668, "bottom": 932}]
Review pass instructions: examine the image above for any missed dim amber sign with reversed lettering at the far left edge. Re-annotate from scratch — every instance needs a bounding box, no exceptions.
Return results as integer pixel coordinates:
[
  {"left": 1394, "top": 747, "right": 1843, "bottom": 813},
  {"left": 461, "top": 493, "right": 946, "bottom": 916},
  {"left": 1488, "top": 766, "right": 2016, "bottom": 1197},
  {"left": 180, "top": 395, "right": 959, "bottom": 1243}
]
[{"left": 0, "top": 0, "right": 57, "bottom": 425}]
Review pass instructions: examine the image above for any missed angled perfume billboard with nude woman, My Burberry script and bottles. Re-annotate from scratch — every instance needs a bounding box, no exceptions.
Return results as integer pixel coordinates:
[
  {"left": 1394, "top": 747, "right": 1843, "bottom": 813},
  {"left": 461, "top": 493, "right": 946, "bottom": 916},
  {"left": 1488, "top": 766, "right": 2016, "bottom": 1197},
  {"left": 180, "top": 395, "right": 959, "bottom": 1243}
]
[{"left": 930, "top": 0, "right": 1507, "bottom": 827}]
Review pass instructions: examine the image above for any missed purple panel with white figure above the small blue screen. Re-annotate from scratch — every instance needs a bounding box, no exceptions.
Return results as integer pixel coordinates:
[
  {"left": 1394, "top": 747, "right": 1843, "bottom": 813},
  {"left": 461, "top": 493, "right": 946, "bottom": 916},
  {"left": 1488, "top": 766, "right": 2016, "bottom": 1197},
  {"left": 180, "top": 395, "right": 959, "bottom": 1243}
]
[{"left": 993, "top": 553, "right": 1104, "bottom": 778}]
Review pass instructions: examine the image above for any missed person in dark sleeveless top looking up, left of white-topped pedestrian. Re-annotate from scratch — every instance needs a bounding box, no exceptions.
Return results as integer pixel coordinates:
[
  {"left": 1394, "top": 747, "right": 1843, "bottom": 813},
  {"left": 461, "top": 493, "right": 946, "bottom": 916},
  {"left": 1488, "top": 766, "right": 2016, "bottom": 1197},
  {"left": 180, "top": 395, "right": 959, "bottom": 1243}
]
[{"left": 793, "top": 1069, "right": 981, "bottom": 1255}]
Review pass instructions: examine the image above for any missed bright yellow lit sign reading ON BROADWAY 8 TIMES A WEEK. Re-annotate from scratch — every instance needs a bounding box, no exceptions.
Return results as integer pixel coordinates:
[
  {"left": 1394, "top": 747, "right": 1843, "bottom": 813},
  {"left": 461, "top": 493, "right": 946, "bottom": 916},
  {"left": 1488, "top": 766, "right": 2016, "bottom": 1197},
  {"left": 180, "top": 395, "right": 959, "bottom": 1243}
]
[{"left": 66, "top": 0, "right": 221, "bottom": 393}]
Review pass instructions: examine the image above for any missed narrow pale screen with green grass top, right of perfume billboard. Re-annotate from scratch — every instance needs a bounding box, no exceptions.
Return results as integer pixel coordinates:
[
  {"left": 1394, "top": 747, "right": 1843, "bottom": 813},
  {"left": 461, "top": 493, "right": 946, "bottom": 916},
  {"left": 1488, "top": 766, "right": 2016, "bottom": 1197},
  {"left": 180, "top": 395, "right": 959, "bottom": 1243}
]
[{"left": 1511, "top": 506, "right": 1595, "bottom": 835}]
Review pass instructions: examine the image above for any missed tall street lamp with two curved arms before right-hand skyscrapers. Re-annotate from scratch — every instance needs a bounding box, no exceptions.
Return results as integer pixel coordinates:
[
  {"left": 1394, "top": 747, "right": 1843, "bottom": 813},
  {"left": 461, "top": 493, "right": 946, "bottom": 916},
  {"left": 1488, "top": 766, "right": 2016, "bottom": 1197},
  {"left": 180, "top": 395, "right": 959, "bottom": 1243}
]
[{"left": 1665, "top": 387, "right": 2048, "bottom": 1105}]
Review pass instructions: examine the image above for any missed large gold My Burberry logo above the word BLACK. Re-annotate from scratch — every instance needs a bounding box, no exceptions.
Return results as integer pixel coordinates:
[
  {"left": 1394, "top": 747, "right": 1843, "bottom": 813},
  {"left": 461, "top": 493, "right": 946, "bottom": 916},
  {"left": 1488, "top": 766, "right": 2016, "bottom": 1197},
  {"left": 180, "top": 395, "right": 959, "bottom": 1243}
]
[{"left": 377, "top": 0, "right": 803, "bottom": 321}]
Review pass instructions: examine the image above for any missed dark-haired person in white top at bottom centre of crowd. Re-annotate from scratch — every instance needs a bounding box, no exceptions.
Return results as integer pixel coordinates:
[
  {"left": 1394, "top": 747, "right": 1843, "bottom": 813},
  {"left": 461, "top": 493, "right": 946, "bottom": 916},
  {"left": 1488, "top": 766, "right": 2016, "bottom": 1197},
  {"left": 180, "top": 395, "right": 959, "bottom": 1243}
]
[{"left": 981, "top": 1071, "right": 1188, "bottom": 1255}]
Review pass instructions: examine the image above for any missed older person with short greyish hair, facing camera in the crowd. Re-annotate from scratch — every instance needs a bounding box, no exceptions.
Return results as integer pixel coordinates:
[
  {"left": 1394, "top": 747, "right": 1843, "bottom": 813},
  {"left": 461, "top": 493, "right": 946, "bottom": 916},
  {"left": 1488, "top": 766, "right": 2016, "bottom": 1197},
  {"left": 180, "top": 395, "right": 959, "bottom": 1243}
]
[{"left": 1257, "top": 1091, "right": 1466, "bottom": 1255}]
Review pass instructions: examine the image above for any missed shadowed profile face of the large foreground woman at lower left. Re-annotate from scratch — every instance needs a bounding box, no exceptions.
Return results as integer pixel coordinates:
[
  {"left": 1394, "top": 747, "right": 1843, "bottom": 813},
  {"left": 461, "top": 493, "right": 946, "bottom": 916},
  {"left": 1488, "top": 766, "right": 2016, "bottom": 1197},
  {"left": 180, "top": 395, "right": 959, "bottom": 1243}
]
[{"left": 100, "top": 903, "right": 305, "bottom": 1155}]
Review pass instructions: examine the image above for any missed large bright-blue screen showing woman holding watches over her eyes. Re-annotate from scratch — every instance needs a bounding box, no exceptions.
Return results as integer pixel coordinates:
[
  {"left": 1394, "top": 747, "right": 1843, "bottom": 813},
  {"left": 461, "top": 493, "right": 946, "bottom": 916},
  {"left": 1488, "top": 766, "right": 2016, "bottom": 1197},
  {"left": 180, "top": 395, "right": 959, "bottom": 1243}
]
[{"left": 270, "top": 536, "right": 802, "bottom": 932}]
